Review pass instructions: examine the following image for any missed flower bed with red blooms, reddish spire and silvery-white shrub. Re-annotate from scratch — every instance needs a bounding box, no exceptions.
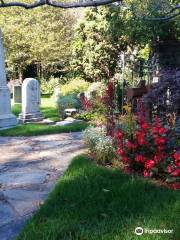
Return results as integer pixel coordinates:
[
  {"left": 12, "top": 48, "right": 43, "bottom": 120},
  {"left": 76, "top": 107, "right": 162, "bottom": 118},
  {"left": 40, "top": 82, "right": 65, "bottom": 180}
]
[{"left": 84, "top": 82, "right": 180, "bottom": 189}]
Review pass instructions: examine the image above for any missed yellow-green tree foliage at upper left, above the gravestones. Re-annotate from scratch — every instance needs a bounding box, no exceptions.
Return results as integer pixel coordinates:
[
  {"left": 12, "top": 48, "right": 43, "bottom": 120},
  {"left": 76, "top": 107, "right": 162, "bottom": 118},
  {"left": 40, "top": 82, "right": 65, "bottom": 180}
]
[{"left": 0, "top": 6, "right": 75, "bottom": 77}]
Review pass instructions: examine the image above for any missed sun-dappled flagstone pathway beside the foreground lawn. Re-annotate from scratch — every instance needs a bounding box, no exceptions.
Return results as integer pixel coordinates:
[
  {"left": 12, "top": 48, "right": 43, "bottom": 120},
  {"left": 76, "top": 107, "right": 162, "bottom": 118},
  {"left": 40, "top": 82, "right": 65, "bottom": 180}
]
[{"left": 0, "top": 133, "right": 84, "bottom": 240}]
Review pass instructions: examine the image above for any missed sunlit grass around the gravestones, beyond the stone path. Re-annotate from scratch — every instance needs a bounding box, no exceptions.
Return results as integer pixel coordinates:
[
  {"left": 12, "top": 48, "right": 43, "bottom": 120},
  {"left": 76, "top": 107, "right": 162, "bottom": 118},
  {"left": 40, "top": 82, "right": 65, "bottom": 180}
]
[{"left": 0, "top": 97, "right": 88, "bottom": 136}]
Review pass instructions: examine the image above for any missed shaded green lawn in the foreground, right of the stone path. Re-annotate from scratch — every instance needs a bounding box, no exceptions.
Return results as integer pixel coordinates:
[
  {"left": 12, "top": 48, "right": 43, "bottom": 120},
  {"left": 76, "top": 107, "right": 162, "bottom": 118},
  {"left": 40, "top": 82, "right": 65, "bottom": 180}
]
[{"left": 17, "top": 156, "right": 180, "bottom": 240}]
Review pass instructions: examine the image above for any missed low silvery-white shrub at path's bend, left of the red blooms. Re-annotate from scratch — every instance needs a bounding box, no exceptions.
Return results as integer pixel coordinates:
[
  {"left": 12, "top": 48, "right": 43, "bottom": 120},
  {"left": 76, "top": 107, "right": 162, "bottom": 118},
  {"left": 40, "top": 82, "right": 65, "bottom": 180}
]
[{"left": 83, "top": 126, "right": 114, "bottom": 164}]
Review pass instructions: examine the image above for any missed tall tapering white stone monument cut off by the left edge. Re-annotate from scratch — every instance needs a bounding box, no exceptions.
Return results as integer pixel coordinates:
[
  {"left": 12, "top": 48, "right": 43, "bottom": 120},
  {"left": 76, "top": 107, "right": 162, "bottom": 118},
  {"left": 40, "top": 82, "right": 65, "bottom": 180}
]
[{"left": 0, "top": 31, "right": 17, "bottom": 128}]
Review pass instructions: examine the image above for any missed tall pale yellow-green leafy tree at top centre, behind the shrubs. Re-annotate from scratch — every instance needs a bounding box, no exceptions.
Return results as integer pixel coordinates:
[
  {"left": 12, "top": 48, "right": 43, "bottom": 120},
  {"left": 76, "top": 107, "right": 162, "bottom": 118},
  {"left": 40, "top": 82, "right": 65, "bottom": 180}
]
[{"left": 72, "top": 7, "right": 119, "bottom": 82}]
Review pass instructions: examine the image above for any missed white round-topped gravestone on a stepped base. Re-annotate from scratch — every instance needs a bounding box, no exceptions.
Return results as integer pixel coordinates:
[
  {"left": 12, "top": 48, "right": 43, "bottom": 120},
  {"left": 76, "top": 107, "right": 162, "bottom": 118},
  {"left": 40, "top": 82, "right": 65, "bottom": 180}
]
[{"left": 19, "top": 78, "right": 43, "bottom": 123}]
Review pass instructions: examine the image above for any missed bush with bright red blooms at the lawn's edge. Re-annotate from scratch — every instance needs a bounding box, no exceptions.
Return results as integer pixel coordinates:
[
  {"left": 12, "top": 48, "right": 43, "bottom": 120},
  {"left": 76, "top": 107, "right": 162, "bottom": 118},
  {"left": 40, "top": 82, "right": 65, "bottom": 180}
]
[{"left": 114, "top": 117, "right": 180, "bottom": 185}]
